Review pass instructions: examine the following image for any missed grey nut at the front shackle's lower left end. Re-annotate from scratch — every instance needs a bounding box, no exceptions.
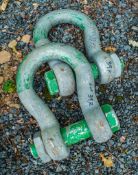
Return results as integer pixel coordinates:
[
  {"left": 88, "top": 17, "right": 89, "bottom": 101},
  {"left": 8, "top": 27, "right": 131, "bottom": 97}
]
[{"left": 33, "top": 132, "right": 51, "bottom": 163}]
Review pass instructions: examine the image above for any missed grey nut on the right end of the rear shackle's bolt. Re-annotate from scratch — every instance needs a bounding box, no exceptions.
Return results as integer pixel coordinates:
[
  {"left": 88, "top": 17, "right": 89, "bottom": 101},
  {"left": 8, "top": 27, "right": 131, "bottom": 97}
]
[{"left": 110, "top": 53, "right": 122, "bottom": 78}]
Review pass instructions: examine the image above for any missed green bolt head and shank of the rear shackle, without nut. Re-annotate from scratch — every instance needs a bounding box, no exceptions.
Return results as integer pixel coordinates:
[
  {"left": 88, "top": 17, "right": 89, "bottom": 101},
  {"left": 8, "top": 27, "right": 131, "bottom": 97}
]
[{"left": 44, "top": 64, "right": 99, "bottom": 96}]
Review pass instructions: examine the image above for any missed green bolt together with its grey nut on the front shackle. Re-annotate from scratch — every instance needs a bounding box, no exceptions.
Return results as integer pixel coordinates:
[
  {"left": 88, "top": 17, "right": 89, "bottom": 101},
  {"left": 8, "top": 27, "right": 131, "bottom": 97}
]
[{"left": 30, "top": 104, "right": 120, "bottom": 163}]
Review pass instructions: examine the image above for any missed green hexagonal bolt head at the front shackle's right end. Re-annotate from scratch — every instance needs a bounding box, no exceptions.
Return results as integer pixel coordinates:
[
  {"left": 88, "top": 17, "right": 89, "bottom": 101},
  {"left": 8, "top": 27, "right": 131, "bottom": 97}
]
[{"left": 102, "top": 104, "right": 120, "bottom": 133}]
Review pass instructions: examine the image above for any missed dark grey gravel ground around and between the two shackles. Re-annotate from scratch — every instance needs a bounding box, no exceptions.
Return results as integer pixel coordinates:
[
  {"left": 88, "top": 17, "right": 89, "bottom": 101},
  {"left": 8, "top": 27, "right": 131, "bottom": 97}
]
[{"left": 0, "top": 0, "right": 138, "bottom": 175}]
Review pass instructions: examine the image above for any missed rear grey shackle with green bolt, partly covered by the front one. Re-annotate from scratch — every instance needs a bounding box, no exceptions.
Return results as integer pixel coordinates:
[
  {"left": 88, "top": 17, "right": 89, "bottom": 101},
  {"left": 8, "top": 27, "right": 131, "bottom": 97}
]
[{"left": 33, "top": 9, "right": 123, "bottom": 96}]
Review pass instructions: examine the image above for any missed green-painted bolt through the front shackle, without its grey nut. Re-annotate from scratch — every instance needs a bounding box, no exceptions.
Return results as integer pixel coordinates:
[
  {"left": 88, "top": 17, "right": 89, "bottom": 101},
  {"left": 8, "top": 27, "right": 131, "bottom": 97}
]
[{"left": 30, "top": 104, "right": 120, "bottom": 158}]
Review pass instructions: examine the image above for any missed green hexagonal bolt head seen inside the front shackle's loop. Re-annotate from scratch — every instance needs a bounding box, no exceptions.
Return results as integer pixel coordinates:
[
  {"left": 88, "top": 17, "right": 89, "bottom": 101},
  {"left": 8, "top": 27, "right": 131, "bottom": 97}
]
[{"left": 44, "top": 70, "right": 59, "bottom": 95}]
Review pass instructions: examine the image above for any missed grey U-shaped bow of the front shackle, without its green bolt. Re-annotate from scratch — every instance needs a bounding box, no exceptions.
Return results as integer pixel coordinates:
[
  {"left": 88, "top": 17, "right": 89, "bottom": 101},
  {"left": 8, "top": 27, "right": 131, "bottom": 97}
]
[{"left": 17, "top": 43, "right": 118, "bottom": 162}]
